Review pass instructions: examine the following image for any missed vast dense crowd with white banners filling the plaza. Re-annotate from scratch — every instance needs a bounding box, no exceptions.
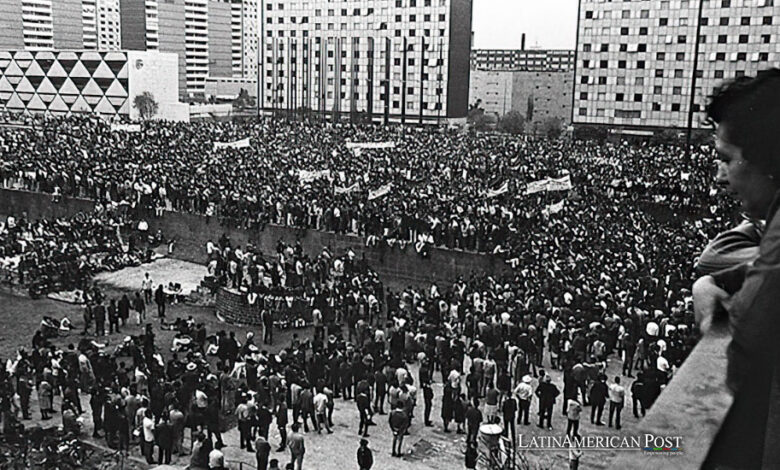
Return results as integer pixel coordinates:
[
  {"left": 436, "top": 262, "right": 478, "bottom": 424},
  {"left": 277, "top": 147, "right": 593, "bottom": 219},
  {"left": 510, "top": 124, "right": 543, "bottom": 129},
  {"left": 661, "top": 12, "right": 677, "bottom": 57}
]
[{"left": 0, "top": 114, "right": 748, "bottom": 469}]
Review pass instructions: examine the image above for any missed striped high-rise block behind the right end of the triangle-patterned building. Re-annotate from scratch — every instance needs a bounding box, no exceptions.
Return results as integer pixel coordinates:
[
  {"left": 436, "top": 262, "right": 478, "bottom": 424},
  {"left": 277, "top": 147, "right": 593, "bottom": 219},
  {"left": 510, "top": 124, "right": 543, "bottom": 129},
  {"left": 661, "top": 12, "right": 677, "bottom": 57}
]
[{"left": 120, "top": 0, "right": 258, "bottom": 97}]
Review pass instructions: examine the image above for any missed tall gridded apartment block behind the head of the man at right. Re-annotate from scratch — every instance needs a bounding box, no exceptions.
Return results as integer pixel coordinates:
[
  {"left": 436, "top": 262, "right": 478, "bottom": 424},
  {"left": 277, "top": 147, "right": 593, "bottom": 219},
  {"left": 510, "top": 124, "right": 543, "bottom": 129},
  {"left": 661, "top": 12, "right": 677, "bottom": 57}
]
[{"left": 572, "top": 0, "right": 780, "bottom": 128}]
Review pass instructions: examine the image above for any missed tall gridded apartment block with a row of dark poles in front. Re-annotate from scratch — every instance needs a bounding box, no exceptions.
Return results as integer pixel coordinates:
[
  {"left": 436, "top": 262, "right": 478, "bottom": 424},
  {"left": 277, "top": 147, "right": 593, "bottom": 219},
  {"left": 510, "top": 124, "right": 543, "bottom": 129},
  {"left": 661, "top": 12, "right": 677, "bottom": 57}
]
[{"left": 259, "top": 0, "right": 472, "bottom": 123}]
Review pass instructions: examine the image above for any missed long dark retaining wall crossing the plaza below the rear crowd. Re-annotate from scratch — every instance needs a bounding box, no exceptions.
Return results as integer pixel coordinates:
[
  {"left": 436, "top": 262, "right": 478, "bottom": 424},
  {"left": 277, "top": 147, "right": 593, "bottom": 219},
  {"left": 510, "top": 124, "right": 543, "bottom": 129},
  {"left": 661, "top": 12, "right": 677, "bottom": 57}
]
[{"left": 0, "top": 189, "right": 509, "bottom": 288}]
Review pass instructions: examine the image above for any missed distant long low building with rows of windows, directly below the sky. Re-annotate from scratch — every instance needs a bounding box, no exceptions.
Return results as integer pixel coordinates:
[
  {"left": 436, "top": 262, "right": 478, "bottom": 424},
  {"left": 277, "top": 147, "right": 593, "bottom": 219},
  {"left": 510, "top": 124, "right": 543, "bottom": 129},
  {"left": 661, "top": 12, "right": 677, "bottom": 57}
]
[{"left": 471, "top": 49, "right": 574, "bottom": 72}]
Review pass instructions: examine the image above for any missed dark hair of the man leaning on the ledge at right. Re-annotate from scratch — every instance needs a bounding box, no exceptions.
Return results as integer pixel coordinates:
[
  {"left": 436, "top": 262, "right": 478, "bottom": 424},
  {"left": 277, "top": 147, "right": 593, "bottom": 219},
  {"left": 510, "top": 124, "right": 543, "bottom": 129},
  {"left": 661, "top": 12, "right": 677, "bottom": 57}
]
[{"left": 707, "top": 68, "right": 780, "bottom": 176}]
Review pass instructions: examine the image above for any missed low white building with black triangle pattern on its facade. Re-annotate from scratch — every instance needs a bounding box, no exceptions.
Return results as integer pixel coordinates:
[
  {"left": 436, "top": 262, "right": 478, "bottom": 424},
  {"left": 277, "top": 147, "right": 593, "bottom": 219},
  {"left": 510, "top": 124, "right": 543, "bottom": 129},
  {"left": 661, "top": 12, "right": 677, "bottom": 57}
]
[{"left": 0, "top": 50, "right": 189, "bottom": 120}]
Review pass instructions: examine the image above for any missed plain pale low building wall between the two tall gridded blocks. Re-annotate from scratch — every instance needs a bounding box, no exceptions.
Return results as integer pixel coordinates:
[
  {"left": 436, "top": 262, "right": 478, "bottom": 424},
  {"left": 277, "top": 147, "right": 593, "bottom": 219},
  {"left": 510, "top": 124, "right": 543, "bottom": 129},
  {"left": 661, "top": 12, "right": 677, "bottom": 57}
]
[{"left": 469, "top": 70, "right": 574, "bottom": 124}]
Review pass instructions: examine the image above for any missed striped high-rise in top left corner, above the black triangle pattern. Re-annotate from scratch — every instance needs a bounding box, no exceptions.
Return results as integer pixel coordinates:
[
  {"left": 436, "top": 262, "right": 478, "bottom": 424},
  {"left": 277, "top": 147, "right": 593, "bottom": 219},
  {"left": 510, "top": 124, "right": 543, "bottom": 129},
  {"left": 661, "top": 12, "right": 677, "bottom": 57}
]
[{"left": 0, "top": 0, "right": 119, "bottom": 51}]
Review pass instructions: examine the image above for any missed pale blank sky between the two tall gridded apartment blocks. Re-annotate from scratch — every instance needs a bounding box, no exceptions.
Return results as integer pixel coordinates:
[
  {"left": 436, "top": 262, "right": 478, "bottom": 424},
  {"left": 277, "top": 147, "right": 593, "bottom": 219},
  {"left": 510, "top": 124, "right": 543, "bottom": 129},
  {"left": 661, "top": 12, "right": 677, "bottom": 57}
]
[{"left": 472, "top": 0, "right": 577, "bottom": 49}]
